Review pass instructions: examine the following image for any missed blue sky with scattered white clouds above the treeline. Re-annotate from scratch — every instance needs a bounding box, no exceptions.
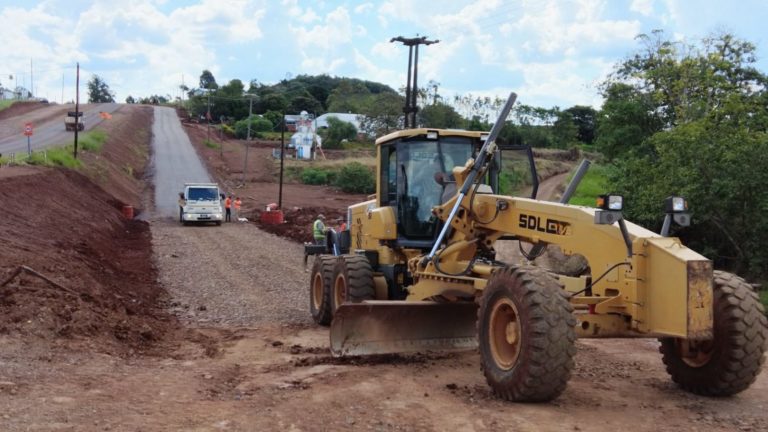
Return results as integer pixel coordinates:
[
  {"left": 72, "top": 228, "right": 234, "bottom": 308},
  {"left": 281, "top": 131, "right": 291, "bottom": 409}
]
[{"left": 0, "top": 0, "right": 768, "bottom": 108}]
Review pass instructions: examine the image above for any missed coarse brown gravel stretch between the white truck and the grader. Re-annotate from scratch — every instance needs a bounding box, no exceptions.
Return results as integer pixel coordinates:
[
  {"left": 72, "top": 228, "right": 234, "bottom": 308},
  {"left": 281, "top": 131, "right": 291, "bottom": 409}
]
[{"left": 152, "top": 219, "right": 311, "bottom": 327}]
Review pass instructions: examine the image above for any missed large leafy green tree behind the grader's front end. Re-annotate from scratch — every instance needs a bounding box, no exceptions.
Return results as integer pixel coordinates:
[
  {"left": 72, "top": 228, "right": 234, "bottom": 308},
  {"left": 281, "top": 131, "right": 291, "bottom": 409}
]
[{"left": 608, "top": 32, "right": 768, "bottom": 278}]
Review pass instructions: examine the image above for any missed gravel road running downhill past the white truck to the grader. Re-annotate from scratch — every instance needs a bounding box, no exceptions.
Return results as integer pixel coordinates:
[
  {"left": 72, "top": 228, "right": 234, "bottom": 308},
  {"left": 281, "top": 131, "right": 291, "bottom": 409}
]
[{"left": 152, "top": 107, "right": 310, "bottom": 327}]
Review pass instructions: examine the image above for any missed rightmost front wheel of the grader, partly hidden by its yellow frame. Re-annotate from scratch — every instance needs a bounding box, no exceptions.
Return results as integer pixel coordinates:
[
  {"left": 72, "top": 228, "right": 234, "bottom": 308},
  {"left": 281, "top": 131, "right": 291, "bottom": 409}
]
[{"left": 659, "top": 271, "right": 768, "bottom": 396}]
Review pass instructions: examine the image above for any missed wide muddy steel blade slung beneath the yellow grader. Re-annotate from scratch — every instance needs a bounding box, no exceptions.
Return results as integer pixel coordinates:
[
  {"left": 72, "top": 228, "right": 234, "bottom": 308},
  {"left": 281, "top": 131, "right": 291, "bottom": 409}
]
[{"left": 331, "top": 300, "right": 477, "bottom": 357}]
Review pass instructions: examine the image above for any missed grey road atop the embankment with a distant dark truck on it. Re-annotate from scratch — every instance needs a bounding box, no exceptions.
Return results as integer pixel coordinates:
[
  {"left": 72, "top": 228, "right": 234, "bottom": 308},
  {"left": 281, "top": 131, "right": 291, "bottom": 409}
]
[{"left": 0, "top": 103, "right": 121, "bottom": 156}]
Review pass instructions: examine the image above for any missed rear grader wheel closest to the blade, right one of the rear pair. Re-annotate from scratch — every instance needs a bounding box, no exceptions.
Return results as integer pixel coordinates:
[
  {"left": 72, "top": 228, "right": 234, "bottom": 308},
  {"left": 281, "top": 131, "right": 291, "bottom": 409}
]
[{"left": 331, "top": 255, "right": 376, "bottom": 311}]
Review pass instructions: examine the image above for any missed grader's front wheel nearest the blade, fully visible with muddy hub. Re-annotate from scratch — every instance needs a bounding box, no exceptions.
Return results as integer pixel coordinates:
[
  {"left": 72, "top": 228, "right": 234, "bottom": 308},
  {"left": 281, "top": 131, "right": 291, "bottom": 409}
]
[{"left": 477, "top": 267, "right": 576, "bottom": 402}]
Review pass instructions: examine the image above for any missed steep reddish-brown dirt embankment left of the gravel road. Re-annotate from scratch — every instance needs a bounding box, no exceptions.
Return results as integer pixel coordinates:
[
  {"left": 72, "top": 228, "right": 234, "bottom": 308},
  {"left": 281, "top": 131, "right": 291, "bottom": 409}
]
[{"left": 0, "top": 107, "right": 173, "bottom": 353}]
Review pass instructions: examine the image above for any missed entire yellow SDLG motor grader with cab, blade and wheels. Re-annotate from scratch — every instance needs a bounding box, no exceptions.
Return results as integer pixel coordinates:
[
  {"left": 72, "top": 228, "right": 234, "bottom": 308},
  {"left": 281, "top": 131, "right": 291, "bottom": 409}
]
[{"left": 309, "top": 93, "right": 768, "bottom": 402}]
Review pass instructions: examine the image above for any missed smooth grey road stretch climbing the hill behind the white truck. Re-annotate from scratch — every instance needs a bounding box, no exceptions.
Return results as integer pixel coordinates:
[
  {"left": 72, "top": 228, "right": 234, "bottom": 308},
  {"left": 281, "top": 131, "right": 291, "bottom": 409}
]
[{"left": 152, "top": 107, "right": 211, "bottom": 217}]
